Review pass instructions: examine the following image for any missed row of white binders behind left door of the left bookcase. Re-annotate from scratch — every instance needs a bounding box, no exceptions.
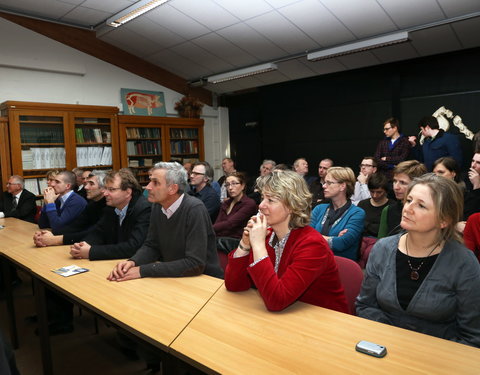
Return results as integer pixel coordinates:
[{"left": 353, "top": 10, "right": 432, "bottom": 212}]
[{"left": 22, "top": 147, "right": 65, "bottom": 169}]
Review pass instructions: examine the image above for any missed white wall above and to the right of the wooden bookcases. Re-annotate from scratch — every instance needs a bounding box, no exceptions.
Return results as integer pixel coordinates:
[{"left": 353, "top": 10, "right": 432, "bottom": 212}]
[{"left": 0, "top": 18, "right": 229, "bottom": 175}]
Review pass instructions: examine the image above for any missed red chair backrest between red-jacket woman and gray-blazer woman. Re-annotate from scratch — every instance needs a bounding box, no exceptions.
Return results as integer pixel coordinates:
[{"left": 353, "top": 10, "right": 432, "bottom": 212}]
[{"left": 335, "top": 256, "right": 363, "bottom": 315}]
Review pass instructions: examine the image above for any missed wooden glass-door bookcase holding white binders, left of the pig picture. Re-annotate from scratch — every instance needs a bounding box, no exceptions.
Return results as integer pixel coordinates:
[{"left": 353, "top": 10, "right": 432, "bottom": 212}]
[{"left": 0, "top": 101, "right": 120, "bottom": 194}]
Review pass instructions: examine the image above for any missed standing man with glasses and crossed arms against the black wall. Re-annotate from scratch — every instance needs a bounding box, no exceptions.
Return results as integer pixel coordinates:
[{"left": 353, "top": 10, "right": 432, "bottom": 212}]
[{"left": 374, "top": 117, "right": 411, "bottom": 181}]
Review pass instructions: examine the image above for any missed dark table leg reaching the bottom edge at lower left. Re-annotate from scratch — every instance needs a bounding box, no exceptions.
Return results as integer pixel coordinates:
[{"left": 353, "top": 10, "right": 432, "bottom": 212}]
[{"left": 33, "top": 277, "right": 53, "bottom": 375}]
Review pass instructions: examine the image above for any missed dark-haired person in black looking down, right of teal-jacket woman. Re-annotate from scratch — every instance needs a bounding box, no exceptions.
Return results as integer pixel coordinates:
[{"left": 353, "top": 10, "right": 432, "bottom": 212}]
[{"left": 358, "top": 173, "right": 393, "bottom": 237}]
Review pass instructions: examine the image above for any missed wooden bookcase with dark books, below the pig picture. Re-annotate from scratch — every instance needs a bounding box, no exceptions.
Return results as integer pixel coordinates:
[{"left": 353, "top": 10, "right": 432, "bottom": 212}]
[{"left": 118, "top": 115, "right": 205, "bottom": 185}]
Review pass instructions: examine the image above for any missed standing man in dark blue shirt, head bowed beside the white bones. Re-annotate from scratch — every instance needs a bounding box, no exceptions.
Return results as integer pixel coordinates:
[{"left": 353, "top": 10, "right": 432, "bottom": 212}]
[{"left": 408, "top": 116, "right": 463, "bottom": 171}]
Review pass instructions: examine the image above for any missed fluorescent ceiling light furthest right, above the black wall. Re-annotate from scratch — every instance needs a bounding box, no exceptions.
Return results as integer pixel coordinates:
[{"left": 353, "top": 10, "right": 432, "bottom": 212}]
[{"left": 307, "top": 32, "right": 408, "bottom": 61}]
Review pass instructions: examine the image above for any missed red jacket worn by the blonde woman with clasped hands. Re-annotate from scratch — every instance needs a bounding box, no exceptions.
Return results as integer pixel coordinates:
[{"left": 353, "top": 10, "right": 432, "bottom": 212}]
[{"left": 225, "top": 226, "right": 348, "bottom": 313}]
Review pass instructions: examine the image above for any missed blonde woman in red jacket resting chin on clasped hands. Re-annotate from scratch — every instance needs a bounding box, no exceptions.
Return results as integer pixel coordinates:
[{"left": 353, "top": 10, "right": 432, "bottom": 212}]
[{"left": 225, "top": 170, "right": 348, "bottom": 312}]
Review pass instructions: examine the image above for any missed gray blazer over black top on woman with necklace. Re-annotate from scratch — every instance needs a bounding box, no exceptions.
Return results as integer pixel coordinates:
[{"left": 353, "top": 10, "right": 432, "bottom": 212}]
[{"left": 356, "top": 235, "right": 480, "bottom": 347}]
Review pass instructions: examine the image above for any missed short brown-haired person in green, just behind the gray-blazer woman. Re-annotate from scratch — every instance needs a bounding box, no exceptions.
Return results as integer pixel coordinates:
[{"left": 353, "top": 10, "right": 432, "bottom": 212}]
[{"left": 378, "top": 160, "right": 427, "bottom": 238}]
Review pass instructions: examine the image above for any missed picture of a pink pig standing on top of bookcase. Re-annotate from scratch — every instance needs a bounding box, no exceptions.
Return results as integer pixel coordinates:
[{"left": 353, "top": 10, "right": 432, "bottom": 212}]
[{"left": 120, "top": 89, "right": 167, "bottom": 116}]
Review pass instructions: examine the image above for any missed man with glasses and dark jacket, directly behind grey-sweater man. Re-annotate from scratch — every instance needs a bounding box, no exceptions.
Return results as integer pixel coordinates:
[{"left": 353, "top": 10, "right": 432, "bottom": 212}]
[{"left": 188, "top": 161, "right": 220, "bottom": 223}]
